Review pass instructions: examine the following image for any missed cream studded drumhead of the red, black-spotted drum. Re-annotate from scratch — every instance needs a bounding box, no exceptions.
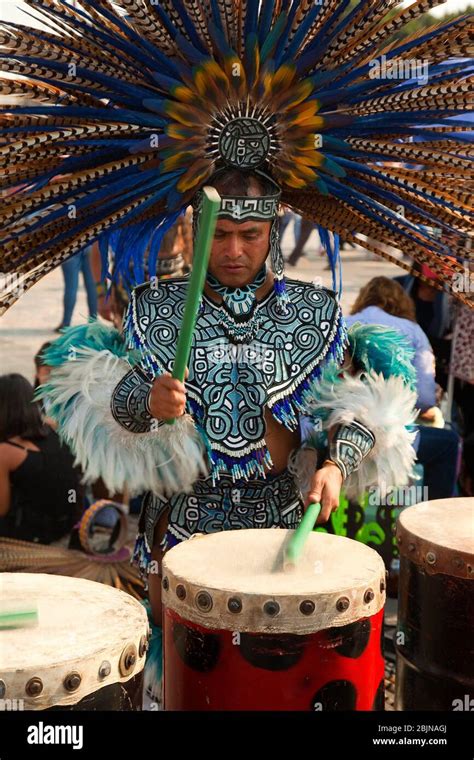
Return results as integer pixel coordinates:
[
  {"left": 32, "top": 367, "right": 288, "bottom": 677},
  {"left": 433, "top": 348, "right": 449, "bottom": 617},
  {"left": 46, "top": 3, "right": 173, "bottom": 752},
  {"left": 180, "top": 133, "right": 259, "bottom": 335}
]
[{"left": 163, "top": 529, "right": 385, "bottom": 634}]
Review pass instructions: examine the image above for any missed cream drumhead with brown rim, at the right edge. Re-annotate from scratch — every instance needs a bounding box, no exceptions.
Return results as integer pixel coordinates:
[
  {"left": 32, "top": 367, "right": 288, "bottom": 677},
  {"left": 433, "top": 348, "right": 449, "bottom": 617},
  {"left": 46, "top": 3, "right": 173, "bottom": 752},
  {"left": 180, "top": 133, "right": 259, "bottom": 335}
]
[{"left": 397, "top": 497, "right": 474, "bottom": 579}]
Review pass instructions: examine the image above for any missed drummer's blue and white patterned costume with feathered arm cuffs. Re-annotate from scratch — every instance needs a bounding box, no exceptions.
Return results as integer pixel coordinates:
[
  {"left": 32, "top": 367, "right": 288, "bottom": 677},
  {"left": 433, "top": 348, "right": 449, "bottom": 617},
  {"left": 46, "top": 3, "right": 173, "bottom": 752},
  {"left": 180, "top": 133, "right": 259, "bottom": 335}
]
[{"left": 43, "top": 260, "right": 415, "bottom": 579}]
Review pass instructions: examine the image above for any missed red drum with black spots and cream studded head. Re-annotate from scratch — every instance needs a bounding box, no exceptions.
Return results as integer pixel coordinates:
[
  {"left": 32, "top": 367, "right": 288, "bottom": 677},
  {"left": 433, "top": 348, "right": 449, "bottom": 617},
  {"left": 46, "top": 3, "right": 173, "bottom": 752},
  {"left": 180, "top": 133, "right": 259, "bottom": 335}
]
[{"left": 163, "top": 530, "right": 385, "bottom": 710}]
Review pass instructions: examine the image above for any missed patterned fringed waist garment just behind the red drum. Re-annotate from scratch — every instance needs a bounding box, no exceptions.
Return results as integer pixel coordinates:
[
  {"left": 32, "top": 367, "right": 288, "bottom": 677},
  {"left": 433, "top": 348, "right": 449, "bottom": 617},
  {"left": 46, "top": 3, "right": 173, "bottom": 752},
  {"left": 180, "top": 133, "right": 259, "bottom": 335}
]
[{"left": 134, "top": 470, "right": 303, "bottom": 574}]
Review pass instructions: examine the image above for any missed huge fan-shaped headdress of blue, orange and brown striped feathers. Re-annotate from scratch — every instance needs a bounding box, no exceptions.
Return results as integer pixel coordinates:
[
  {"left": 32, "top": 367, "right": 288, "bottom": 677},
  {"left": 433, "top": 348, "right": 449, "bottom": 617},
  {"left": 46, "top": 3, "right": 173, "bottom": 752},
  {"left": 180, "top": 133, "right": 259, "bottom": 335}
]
[{"left": 0, "top": 0, "right": 473, "bottom": 309}]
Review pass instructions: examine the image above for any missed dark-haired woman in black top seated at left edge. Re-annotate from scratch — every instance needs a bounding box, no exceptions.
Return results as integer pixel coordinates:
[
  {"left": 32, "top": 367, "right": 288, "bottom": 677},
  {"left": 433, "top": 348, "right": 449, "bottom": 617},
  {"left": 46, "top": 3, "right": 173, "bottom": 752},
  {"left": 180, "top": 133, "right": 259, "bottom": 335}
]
[{"left": 0, "top": 374, "right": 83, "bottom": 544}]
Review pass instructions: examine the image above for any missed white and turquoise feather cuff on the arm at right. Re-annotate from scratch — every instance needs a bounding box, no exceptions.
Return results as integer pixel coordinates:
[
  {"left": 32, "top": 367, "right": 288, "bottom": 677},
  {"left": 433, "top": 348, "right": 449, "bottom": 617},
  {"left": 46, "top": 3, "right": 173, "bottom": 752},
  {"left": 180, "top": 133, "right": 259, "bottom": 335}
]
[{"left": 295, "top": 323, "right": 416, "bottom": 498}]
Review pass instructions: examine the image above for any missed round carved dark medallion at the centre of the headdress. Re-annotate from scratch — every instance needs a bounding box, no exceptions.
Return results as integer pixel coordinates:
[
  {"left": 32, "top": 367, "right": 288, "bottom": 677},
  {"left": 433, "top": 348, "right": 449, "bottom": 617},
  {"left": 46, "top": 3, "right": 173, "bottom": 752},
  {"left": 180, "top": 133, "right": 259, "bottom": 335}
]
[{"left": 219, "top": 116, "right": 270, "bottom": 169}]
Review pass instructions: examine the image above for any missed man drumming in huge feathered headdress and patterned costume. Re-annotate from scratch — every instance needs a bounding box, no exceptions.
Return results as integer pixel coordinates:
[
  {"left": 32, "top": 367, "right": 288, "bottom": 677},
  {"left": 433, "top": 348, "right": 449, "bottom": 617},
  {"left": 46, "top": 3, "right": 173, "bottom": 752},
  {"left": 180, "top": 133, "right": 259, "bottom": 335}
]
[{"left": 0, "top": 0, "right": 473, "bottom": 704}]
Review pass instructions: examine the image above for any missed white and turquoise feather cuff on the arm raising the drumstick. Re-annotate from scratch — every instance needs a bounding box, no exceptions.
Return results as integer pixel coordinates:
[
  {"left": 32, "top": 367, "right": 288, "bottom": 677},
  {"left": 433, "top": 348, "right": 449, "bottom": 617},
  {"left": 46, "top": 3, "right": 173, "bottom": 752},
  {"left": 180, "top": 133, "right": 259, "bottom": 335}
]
[{"left": 36, "top": 320, "right": 207, "bottom": 496}]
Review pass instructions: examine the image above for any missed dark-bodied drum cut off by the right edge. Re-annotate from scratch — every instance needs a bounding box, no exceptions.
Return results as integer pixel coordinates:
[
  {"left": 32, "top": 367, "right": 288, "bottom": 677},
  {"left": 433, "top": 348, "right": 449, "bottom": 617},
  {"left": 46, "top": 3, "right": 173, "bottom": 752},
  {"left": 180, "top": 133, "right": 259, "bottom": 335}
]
[{"left": 395, "top": 498, "right": 474, "bottom": 711}]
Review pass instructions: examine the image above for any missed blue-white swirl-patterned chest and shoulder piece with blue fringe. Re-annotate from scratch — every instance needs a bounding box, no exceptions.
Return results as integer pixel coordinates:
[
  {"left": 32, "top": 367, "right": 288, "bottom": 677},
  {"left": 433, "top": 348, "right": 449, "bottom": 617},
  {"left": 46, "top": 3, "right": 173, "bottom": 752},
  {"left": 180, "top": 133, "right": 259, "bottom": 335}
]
[{"left": 124, "top": 277, "right": 345, "bottom": 479}]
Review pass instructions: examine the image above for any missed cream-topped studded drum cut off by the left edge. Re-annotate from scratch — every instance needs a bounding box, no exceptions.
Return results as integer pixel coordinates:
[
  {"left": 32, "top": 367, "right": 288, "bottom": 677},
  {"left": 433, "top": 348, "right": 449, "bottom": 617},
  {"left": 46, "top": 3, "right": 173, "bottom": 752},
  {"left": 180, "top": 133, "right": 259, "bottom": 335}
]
[{"left": 0, "top": 573, "right": 148, "bottom": 710}]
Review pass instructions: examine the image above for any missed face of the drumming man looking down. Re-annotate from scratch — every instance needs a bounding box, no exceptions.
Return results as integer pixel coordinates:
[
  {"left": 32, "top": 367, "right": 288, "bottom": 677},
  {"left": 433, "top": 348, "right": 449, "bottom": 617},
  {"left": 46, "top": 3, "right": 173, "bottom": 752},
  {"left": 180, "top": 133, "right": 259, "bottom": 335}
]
[{"left": 209, "top": 219, "right": 271, "bottom": 288}]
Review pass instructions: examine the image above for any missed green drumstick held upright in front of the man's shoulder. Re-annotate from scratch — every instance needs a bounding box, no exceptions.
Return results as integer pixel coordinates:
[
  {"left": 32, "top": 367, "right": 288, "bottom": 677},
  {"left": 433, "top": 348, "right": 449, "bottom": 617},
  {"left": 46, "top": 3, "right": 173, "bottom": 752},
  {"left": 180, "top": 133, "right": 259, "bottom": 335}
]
[{"left": 165, "top": 186, "right": 221, "bottom": 425}]
